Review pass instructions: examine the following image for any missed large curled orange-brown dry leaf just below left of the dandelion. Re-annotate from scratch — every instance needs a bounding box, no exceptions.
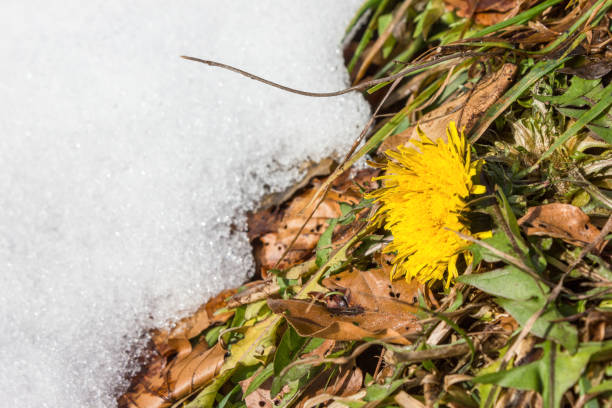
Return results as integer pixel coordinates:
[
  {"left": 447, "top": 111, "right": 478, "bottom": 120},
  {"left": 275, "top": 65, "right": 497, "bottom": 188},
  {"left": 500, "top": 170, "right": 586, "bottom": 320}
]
[{"left": 268, "top": 269, "right": 420, "bottom": 344}]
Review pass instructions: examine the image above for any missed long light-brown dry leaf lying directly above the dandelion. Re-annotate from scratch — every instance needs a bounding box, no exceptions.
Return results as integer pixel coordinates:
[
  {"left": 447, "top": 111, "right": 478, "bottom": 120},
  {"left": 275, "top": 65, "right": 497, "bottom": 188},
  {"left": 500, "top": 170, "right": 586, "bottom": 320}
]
[{"left": 378, "top": 64, "right": 516, "bottom": 153}]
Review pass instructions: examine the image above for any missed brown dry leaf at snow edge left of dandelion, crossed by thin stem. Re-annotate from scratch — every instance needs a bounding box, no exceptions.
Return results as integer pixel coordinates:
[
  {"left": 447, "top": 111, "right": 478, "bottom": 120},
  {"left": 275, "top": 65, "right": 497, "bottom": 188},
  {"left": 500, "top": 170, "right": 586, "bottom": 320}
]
[{"left": 248, "top": 169, "right": 375, "bottom": 277}]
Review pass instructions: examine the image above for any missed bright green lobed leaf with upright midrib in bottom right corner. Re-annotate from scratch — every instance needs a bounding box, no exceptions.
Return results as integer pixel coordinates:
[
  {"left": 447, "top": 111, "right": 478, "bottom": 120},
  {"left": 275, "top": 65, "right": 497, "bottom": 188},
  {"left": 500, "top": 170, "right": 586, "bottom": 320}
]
[{"left": 473, "top": 341, "right": 612, "bottom": 407}]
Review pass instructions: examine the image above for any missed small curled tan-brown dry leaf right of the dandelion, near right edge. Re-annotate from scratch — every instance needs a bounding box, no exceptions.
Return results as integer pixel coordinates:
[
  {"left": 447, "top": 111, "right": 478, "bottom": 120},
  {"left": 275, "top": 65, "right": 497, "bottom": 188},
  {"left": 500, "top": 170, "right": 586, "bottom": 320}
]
[{"left": 518, "top": 203, "right": 607, "bottom": 252}]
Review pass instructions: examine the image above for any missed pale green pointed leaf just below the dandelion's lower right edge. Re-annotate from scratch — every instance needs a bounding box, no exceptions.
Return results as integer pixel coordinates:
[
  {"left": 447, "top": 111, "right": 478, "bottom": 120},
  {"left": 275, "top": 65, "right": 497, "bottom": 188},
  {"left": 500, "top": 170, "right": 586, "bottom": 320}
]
[{"left": 457, "top": 265, "right": 548, "bottom": 300}]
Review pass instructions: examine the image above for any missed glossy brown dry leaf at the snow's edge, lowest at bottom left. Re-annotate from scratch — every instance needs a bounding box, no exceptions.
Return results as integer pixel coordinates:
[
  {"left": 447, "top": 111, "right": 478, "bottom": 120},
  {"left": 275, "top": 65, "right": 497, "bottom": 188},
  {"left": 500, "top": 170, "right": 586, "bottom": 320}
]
[{"left": 118, "top": 342, "right": 226, "bottom": 408}]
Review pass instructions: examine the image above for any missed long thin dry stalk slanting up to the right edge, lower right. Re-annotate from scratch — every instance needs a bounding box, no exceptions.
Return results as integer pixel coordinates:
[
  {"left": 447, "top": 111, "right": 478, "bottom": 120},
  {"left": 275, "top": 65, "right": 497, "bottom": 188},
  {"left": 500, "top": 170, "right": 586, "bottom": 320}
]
[{"left": 485, "top": 215, "right": 612, "bottom": 407}]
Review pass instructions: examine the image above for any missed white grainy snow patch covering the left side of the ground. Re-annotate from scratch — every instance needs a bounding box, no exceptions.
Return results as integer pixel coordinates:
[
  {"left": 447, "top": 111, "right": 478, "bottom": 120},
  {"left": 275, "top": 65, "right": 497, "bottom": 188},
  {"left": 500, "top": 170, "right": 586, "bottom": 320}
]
[{"left": 0, "top": 0, "right": 369, "bottom": 408}]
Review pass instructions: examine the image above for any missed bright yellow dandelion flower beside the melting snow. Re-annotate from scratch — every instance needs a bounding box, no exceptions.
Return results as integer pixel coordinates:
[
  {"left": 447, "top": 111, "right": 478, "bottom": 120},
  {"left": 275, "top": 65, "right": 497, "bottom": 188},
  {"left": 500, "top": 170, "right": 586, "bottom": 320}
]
[{"left": 369, "top": 122, "right": 485, "bottom": 287}]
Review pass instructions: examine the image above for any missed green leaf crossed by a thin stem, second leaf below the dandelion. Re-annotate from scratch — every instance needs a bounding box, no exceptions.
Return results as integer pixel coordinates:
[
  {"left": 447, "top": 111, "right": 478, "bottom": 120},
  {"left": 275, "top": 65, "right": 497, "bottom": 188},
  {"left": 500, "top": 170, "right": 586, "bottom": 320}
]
[{"left": 495, "top": 297, "right": 578, "bottom": 352}]
